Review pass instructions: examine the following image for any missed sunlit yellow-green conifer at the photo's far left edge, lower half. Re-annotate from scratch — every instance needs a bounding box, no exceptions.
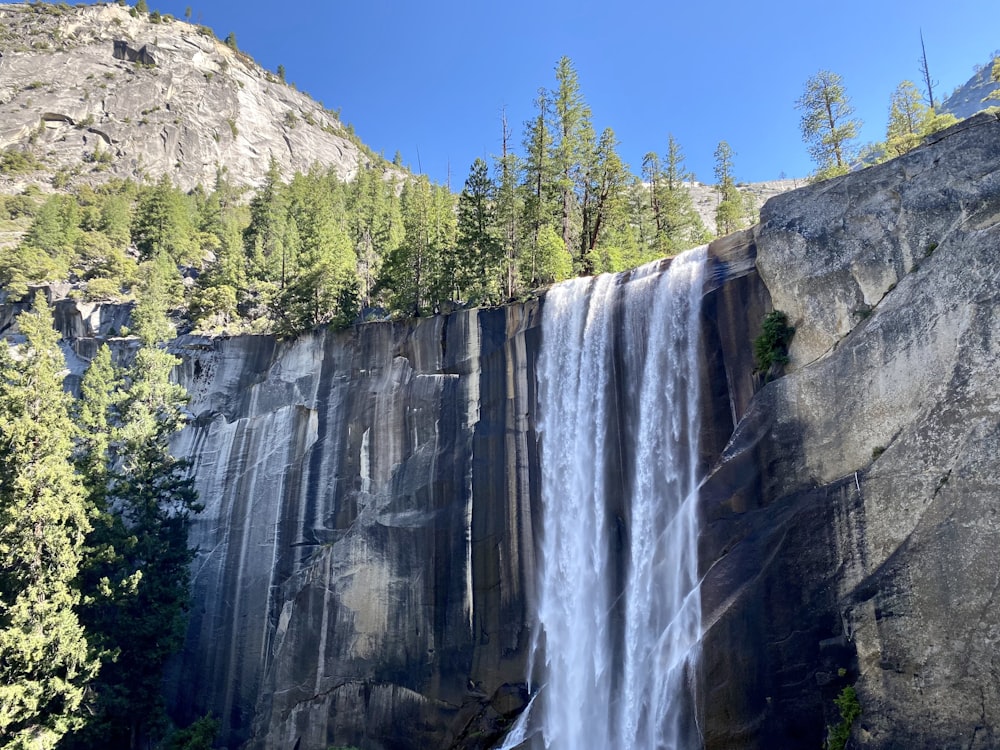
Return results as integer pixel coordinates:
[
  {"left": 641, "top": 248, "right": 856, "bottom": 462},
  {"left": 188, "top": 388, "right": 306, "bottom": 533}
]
[{"left": 0, "top": 295, "right": 98, "bottom": 750}]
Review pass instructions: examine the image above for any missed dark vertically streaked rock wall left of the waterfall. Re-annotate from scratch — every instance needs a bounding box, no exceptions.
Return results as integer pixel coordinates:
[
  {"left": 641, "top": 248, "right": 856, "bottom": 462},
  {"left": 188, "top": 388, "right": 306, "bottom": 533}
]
[{"left": 176, "top": 306, "right": 537, "bottom": 748}]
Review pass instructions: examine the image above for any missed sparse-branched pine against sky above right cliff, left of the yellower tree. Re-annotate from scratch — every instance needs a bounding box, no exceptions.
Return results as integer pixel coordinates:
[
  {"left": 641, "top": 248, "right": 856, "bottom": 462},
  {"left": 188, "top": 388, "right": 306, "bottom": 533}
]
[{"left": 795, "top": 70, "right": 861, "bottom": 179}]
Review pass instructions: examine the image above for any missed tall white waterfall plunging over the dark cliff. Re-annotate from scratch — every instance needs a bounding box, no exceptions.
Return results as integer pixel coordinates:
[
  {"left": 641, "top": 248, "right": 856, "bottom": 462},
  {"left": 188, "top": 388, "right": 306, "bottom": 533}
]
[{"left": 533, "top": 248, "right": 705, "bottom": 750}]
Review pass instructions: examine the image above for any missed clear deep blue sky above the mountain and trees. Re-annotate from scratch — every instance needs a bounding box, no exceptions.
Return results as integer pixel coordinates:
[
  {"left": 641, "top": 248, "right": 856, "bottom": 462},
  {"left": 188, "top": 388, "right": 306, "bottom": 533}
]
[{"left": 127, "top": 0, "right": 1000, "bottom": 189}]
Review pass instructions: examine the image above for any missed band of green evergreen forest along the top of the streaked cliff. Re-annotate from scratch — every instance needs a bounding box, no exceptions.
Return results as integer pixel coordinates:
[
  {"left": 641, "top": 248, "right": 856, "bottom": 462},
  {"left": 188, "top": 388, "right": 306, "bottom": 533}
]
[{"left": 0, "top": 58, "right": 728, "bottom": 336}]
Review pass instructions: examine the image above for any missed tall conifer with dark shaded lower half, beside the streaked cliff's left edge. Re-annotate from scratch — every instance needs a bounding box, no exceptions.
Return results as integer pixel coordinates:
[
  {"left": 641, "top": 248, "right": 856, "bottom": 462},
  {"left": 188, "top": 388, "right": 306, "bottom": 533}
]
[{"left": 66, "top": 326, "right": 200, "bottom": 750}]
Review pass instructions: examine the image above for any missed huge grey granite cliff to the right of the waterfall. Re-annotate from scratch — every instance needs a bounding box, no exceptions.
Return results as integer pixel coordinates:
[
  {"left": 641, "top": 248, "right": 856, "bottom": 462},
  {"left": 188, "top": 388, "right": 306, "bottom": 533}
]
[{"left": 701, "top": 116, "right": 1000, "bottom": 748}]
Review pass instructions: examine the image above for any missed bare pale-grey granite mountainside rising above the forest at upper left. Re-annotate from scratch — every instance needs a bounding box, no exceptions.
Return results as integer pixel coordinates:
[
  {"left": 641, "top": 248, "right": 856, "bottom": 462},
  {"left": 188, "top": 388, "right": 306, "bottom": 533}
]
[{"left": 0, "top": 3, "right": 377, "bottom": 192}]
